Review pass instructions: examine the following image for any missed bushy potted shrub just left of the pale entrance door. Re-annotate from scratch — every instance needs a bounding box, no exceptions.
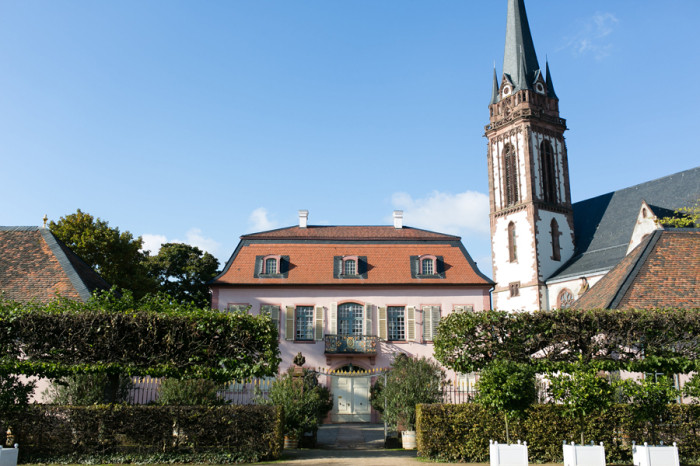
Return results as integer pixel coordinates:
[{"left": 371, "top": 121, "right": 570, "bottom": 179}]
[{"left": 270, "top": 357, "right": 333, "bottom": 448}]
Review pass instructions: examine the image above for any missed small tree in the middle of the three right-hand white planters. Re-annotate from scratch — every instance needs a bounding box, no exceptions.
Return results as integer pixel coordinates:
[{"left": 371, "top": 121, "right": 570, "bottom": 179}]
[{"left": 548, "top": 358, "right": 616, "bottom": 444}]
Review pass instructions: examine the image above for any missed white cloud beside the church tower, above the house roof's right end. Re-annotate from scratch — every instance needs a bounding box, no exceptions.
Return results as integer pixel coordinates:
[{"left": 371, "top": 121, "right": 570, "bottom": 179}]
[{"left": 389, "top": 191, "right": 490, "bottom": 236}]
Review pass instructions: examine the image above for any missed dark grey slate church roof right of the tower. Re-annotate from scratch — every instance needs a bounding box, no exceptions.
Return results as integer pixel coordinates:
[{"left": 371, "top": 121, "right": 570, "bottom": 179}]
[{"left": 547, "top": 167, "right": 700, "bottom": 282}]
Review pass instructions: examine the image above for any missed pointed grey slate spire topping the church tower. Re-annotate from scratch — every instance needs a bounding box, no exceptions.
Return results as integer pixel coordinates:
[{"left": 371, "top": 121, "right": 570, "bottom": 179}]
[{"left": 503, "top": 0, "right": 540, "bottom": 89}]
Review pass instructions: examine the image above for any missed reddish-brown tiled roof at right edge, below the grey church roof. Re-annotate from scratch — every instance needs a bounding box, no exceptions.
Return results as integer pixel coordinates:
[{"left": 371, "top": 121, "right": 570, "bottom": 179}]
[{"left": 572, "top": 228, "right": 700, "bottom": 309}]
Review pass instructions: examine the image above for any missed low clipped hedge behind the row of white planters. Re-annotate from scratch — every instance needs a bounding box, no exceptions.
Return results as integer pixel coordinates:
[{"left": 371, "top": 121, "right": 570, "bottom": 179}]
[{"left": 416, "top": 403, "right": 700, "bottom": 464}]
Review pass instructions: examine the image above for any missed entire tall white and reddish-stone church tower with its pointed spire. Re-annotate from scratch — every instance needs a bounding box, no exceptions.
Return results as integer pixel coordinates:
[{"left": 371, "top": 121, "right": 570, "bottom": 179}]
[{"left": 485, "top": 0, "right": 574, "bottom": 311}]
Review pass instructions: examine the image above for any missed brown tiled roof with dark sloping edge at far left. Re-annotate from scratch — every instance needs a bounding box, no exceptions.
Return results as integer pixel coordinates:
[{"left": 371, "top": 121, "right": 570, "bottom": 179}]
[{"left": 0, "top": 227, "right": 110, "bottom": 302}]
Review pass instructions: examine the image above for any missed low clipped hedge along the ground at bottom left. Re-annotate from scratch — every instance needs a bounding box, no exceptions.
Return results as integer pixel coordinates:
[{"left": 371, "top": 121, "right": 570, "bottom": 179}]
[{"left": 0, "top": 405, "right": 283, "bottom": 463}]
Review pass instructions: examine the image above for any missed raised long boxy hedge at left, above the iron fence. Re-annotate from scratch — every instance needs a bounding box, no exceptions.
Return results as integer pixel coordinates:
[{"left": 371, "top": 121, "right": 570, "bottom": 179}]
[{"left": 0, "top": 293, "right": 280, "bottom": 382}]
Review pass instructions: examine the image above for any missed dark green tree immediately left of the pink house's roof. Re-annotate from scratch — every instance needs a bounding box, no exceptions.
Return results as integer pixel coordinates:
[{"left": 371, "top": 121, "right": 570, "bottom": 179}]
[{"left": 148, "top": 243, "right": 219, "bottom": 307}]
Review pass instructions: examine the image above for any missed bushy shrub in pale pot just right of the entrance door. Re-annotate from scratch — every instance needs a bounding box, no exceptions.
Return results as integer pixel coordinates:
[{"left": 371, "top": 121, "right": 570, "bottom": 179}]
[{"left": 371, "top": 353, "right": 445, "bottom": 449}]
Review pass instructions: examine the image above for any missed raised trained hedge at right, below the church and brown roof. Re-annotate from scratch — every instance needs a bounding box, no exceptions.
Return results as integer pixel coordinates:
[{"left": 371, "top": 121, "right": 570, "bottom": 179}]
[{"left": 435, "top": 309, "right": 700, "bottom": 373}]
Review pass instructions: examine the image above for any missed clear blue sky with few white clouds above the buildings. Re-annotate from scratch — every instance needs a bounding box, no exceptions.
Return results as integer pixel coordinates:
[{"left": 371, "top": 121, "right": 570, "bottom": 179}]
[{"left": 0, "top": 0, "right": 700, "bottom": 274}]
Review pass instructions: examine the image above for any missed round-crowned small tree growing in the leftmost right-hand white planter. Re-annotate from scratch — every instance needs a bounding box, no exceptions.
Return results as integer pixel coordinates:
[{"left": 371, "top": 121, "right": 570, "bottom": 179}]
[{"left": 475, "top": 360, "right": 537, "bottom": 443}]
